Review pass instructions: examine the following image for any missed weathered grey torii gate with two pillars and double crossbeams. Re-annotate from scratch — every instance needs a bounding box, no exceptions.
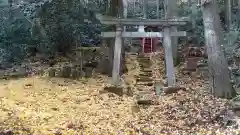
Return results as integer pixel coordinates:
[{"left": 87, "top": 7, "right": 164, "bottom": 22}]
[{"left": 96, "top": 0, "right": 187, "bottom": 86}]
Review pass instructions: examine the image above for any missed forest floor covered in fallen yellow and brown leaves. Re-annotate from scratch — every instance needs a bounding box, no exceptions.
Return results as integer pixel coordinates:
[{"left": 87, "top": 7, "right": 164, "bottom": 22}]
[{"left": 0, "top": 51, "right": 240, "bottom": 135}]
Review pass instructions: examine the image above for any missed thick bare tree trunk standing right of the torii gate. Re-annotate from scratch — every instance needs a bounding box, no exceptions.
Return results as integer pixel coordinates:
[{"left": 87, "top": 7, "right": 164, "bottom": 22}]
[{"left": 201, "top": 0, "right": 236, "bottom": 98}]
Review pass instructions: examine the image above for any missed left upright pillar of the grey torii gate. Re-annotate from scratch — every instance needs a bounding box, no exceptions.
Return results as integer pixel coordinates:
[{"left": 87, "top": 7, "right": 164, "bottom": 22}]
[{"left": 112, "top": 25, "right": 122, "bottom": 86}]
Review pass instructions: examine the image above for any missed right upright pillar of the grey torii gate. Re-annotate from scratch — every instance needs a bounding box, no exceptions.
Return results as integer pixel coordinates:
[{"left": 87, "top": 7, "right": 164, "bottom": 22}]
[{"left": 163, "top": 27, "right": 176, "bottom": 86}]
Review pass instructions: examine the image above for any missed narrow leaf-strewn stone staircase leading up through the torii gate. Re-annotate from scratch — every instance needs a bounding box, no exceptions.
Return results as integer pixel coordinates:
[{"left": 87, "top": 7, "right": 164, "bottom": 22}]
[{"left": 136, "top": 54, "right": 154, "bottom": 104}]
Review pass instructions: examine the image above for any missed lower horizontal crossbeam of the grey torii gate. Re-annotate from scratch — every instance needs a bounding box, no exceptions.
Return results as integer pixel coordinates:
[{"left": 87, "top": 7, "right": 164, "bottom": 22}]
[{"left": 101, "top": 31, "right": 187, "bottom": 38}]
